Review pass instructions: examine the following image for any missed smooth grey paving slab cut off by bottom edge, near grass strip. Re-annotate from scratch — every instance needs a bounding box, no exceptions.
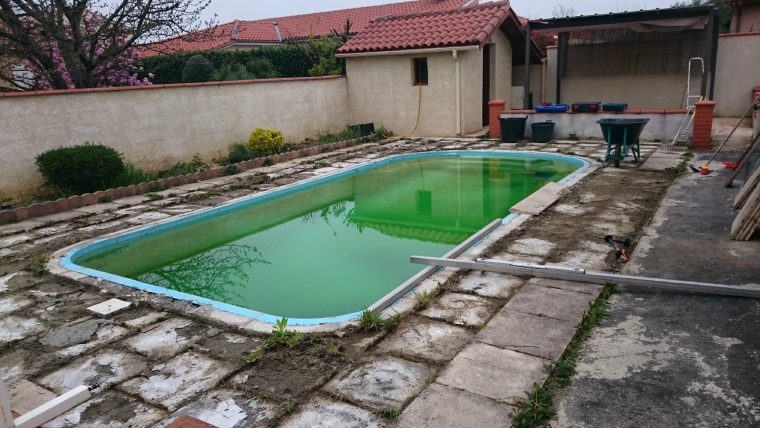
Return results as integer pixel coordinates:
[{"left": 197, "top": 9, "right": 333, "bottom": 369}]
[{"left": 397, "top": 383, "right": 514, "bottom": 428}]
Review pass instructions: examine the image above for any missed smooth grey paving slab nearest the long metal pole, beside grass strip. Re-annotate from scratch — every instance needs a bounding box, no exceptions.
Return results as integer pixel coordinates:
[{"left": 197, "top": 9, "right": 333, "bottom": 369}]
[{"left": 503, "top": 284, "right": 594, "bottom": 323}]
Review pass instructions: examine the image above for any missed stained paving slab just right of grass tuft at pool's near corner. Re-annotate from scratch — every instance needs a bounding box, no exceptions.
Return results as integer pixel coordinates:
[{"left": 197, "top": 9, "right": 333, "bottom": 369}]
[{"left": 377, "top": 317, "right": 472, "bottom": 363}]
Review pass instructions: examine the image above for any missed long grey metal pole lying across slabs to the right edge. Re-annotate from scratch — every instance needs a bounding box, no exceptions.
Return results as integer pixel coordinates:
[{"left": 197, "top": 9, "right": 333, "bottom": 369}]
[{"left": 411, "top": 256, "right": 760, "bottom": 299}]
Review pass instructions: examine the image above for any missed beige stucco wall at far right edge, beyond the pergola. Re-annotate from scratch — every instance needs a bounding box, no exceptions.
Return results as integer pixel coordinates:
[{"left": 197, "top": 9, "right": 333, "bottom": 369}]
[{"left": 715, "top": 33, "right": 760, "bottom": 117}]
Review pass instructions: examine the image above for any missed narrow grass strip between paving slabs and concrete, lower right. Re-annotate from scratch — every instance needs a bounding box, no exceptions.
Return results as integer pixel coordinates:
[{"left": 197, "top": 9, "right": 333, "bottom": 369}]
[{"left": 512, "top": 284, "right": 615, "bottom": 428}]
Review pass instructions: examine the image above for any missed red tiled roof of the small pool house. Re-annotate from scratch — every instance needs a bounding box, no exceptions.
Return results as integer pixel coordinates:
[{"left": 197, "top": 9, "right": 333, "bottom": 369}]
[{"left": 338, "top": 1, "right": 514, "bottom": 54}]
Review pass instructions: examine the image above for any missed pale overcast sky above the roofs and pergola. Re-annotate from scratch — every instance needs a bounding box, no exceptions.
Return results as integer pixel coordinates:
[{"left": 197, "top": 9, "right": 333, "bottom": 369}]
[{"left": 200, "top": 0, "right": 676, "bottom": 23}]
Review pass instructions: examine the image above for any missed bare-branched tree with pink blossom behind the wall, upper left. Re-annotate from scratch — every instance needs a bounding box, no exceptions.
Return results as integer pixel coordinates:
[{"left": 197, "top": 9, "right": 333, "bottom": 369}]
[{"left": 0, "top": 0, "right": 211, "bottom": 90}]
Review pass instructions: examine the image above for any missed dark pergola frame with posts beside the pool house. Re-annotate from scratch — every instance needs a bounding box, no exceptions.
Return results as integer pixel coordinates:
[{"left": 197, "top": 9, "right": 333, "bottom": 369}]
[{"left": 523, "top": 6, "right": 719, "bottom": 109}]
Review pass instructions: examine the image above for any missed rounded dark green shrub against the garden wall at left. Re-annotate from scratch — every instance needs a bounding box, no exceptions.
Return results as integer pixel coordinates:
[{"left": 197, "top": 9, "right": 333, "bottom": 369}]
[{"left": 35, "top": 142, "right": 126, "bottom": 194}]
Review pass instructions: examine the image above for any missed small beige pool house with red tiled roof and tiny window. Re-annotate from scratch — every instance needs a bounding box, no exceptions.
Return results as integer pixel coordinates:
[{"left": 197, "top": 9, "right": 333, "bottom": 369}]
[{"left": 338, "top": 2, "right": 542, "bottom": 136}]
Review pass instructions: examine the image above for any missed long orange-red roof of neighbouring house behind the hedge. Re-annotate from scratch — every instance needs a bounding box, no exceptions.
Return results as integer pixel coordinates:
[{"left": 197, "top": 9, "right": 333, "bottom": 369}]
[{"left": 141, "top": 0, "right": 471, "bottom": 56}]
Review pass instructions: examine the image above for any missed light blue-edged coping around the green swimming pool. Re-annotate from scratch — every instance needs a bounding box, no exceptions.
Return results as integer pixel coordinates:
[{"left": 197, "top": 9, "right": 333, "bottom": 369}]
[{"left": 47, "top": 149, "right": 599, "bottom": 332}]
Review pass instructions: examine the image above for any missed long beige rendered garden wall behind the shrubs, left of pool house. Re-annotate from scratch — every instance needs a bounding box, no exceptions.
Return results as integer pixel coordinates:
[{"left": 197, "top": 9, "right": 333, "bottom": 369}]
[{"left": 0, "top": 76, "right": 349, "bottom": 199}]
